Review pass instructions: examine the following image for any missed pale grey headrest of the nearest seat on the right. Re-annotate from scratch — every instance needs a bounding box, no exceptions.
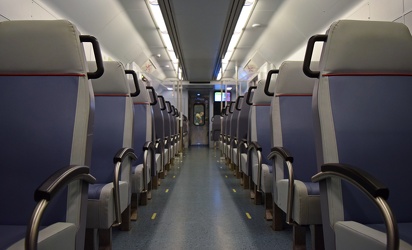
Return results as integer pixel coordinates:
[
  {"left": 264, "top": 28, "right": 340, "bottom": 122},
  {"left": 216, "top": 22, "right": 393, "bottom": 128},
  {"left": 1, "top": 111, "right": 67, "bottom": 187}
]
[{"left": 321, "top": 20, "right": 412, "bottom": 74}]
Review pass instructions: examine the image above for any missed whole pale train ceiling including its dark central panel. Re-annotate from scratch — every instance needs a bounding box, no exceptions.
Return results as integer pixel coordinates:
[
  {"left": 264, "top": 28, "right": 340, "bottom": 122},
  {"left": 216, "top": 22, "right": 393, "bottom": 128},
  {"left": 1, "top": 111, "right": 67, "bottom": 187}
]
[{"left": 39, "top": 0, "right": 362, "bottom": 87}]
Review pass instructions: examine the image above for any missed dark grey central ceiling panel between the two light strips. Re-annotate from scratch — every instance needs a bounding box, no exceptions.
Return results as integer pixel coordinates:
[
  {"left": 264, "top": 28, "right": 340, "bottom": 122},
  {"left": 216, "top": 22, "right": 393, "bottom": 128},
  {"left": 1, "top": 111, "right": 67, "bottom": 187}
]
[{"left": 159, "top": 0, "right": 244, "bottom": 82}]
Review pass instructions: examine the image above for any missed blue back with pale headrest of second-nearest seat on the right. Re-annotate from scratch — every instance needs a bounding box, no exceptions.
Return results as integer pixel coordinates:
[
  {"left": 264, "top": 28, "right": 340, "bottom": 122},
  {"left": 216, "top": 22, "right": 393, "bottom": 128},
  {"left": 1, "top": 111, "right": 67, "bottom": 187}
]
[{"left": 271, "top": 61, "right": 317, "bottom": 198}]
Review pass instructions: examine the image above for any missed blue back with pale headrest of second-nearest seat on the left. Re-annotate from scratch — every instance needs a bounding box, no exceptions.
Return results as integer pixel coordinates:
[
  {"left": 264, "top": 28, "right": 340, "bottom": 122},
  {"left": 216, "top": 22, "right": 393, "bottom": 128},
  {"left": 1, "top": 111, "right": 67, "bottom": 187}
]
[{"left": 89, "top": 61, "right": 133, "bottom": 188}]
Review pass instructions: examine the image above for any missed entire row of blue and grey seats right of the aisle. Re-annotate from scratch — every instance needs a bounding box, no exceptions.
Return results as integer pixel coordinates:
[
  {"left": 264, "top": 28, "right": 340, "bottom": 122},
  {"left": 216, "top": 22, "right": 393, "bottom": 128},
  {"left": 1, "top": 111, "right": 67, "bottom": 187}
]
[{"left": 220, "top": 20, "right": 412, "bottom": 249}]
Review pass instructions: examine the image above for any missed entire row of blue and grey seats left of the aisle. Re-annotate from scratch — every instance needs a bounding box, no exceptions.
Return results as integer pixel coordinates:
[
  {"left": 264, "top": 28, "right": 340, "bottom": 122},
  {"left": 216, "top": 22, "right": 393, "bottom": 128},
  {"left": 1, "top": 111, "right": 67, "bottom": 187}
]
[{"left": 0, "top": 20, "right": 185, "bottom": 249}]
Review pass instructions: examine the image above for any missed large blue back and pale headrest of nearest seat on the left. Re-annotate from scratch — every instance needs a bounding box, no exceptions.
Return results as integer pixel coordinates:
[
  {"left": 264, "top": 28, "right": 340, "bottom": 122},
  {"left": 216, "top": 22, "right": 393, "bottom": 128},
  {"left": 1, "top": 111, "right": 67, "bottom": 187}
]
[{"left": 0, "top": 20, "right": 100, "bottom": 249}]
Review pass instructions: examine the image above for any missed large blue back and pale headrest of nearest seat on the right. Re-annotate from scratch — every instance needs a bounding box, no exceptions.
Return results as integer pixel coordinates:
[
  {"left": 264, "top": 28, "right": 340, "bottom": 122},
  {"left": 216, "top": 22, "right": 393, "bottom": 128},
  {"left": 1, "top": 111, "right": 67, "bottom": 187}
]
[{"left": 306, "top": 20, "right": 412, "bottom": 247}]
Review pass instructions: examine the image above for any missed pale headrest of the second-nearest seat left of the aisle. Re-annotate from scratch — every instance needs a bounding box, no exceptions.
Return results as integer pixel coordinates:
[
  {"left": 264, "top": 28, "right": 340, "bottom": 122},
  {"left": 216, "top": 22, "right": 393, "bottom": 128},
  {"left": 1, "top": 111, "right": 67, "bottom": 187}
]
[{"left": 88, "top": 61, "right": 130, "bottom": 95}]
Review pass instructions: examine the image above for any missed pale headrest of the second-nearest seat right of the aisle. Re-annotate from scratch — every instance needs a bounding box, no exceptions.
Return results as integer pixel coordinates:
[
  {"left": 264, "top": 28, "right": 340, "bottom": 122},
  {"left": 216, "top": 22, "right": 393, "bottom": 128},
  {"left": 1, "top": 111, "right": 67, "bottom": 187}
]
[{"left": 275, "top": 61, "right": 319, "bottom": 95}]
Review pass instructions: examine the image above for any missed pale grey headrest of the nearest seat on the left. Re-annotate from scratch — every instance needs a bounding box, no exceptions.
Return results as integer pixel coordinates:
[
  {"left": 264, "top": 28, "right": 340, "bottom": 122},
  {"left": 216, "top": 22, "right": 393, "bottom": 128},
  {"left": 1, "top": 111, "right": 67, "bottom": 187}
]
[{"left": 0, "top": 20, "right": 87, "bottom": 74}]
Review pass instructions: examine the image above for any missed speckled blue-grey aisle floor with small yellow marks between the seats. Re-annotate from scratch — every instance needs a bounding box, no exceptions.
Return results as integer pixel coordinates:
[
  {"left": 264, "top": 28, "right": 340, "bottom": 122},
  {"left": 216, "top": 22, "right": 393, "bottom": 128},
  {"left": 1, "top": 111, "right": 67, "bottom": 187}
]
[{"left": 113, "top": 147, "right": 292, "bottom": 249}]
